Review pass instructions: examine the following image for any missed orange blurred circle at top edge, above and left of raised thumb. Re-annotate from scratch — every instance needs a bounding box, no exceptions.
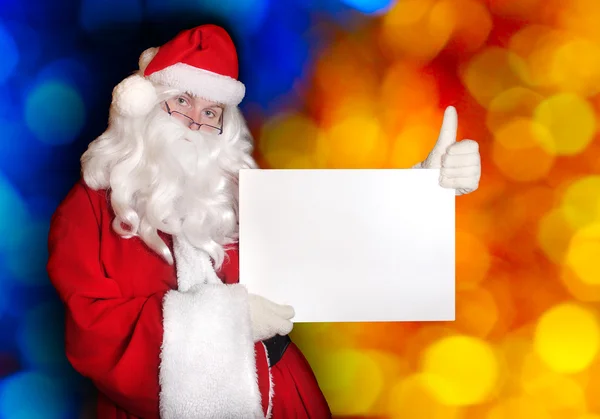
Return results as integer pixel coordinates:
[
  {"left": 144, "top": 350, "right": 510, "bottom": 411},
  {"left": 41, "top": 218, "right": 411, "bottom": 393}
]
[{"left": 380, "top": 0, "right": 456, "bottom": 62}]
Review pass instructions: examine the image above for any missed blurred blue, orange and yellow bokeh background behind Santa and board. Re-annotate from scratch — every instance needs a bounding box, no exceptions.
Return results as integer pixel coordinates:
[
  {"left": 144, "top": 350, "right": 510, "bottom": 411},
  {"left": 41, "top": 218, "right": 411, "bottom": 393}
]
[{"left": 0, "top": 0, "right": 600, "bottom": 419}]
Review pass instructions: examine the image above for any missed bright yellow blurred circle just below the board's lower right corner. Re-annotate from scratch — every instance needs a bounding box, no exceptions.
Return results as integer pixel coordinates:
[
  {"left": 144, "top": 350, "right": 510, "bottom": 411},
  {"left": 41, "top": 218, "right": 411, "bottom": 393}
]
[{"left": 422, "top": 335, "right": 499, "bottom": 406}]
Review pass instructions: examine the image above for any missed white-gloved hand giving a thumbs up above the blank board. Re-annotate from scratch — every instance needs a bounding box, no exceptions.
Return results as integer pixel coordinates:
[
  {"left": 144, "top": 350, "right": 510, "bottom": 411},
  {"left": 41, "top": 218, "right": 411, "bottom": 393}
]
[{"left": 415, "top": 106, "right": 481, "bottom": 195}]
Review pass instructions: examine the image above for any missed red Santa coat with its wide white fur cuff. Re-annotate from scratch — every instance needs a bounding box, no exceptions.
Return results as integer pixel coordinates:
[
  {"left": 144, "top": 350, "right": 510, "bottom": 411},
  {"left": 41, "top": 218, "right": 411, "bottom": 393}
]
[{"left": 48, "top": 182, "right": 331, "bottom": 419}]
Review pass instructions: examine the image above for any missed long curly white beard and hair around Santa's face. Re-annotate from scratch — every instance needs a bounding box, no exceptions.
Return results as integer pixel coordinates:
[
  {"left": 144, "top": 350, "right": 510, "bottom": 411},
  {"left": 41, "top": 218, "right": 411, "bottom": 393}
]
[{"left": 81, "top": 85, "right": 256, "bottom": 269}]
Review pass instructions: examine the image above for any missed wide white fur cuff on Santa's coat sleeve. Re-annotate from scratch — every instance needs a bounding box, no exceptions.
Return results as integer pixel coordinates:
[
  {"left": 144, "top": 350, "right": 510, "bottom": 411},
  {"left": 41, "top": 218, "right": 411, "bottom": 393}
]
[{"left": 159, "top": 284, "right": 264, "bottom": 419}]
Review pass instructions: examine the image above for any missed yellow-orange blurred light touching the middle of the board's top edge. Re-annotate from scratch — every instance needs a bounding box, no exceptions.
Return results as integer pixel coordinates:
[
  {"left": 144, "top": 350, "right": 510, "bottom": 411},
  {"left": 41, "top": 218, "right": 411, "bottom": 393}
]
[{"left": 317, "top": 116, "right": 389, "bottom": 169}]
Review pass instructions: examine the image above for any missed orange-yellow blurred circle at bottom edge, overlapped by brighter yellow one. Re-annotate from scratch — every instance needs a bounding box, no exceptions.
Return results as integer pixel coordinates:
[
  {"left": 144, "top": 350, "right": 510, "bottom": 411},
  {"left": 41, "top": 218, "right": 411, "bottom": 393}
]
[{"left": 388, "top": 374, "right": 462, "bottom": 419}]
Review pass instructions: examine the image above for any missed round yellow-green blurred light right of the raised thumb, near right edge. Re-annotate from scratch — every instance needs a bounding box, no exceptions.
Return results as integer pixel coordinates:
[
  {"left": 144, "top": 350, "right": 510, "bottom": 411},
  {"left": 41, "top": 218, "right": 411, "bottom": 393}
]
[{"left": 534, "top": 93, "right": 596, "bottom": 156}]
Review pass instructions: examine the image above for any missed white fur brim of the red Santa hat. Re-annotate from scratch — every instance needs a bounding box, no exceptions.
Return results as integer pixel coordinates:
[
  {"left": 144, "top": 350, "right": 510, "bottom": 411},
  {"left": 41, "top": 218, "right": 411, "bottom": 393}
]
[{"left": 148, "top": 63, "right": 246, "bottom": 106}]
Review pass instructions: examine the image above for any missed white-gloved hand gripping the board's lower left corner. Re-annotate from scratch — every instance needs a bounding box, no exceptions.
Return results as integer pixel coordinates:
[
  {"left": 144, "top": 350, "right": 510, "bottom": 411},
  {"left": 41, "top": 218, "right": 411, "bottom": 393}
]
[{"left": 248, "top": 294, "right": 296, "bottom": 342}]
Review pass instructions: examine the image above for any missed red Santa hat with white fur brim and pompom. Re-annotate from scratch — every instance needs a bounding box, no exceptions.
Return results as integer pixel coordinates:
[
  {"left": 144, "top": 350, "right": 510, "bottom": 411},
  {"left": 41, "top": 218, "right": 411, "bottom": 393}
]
[{"left": 112, "top": 25, "right": 246, "bottom": 116}]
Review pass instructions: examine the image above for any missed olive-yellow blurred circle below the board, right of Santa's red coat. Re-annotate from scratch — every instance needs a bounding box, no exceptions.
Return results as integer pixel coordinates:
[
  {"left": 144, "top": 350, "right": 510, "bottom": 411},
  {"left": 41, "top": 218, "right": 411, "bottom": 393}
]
[{"left": 319, "top": 349, "right": 383, "bottom": 415}]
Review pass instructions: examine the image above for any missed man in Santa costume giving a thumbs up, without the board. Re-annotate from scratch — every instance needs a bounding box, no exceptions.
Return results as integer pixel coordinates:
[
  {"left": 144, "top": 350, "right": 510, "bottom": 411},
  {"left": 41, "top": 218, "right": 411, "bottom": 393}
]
[{"left": 48, "top": 25, "right": 480, "bottom": 419}]
